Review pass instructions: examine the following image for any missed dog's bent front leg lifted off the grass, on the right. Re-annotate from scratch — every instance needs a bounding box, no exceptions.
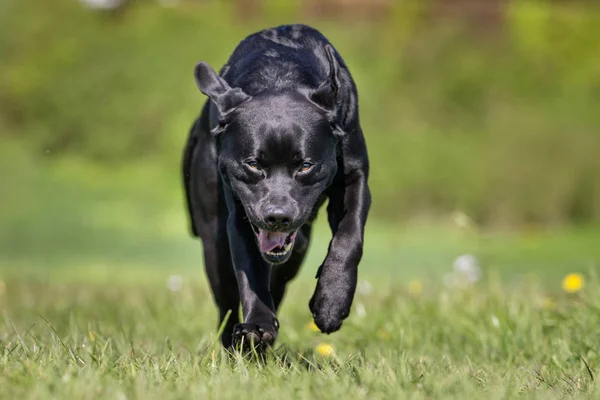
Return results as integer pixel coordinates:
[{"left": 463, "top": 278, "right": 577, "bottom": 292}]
[{"left": 310, "top": 169, "right": 371, "bottom": 333}]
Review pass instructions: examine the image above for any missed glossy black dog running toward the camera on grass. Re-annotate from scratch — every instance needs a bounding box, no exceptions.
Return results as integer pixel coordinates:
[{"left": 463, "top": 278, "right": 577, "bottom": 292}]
[{"left": 183, "top": 25, "right": 371, "bottom": 347}]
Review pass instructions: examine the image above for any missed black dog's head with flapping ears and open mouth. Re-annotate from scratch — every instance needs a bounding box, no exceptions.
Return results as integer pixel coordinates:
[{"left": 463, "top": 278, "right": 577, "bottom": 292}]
[{"left": 195, "top": 46, "right": 342, "bottom": 264}]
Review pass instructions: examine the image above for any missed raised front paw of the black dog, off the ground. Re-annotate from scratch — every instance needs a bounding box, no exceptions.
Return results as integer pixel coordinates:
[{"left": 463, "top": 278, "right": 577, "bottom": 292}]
[{"left": 309, "top": 284, "right": 352, "bottom": 333}]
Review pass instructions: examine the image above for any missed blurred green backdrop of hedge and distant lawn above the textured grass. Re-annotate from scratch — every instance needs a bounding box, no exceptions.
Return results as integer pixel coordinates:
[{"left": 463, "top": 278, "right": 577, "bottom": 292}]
[{"left": 0, "top": 0, "right": 600, "bottom": 284}]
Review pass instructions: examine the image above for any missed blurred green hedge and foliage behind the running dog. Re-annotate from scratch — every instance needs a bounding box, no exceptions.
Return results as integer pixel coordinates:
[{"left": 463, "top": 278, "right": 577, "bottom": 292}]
[{"left": 0, "top": 0, "right": 600, "bottom": 222}]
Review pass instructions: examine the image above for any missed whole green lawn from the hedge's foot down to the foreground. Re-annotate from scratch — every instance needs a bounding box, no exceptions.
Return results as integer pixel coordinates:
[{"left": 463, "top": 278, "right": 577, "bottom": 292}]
[{"left": 0, "top": 224, "right": 600, "bottom": 399}]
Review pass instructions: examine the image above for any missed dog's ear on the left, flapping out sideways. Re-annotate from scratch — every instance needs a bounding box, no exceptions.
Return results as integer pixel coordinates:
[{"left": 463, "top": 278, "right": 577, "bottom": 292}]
[{"left": 194, "top": 61, "right": 252, "bottom": 116}]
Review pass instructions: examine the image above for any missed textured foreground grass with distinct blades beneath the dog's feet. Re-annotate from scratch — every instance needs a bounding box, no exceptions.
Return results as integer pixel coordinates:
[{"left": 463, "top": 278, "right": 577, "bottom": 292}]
[{"left": 0, "top": 270, "right": 600, "bottom": 399}]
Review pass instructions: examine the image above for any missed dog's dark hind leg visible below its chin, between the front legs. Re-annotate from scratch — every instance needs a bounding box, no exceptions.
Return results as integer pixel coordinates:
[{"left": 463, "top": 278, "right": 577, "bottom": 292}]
[{"left": 270, "top": 223, "right": 312, "bottom": 310}]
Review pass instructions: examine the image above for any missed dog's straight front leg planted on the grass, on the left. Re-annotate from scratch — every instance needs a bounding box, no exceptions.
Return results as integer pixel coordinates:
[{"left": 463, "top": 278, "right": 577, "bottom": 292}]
[{"left": 227, "top": 191, "right": 279, "bottom": 348}]
